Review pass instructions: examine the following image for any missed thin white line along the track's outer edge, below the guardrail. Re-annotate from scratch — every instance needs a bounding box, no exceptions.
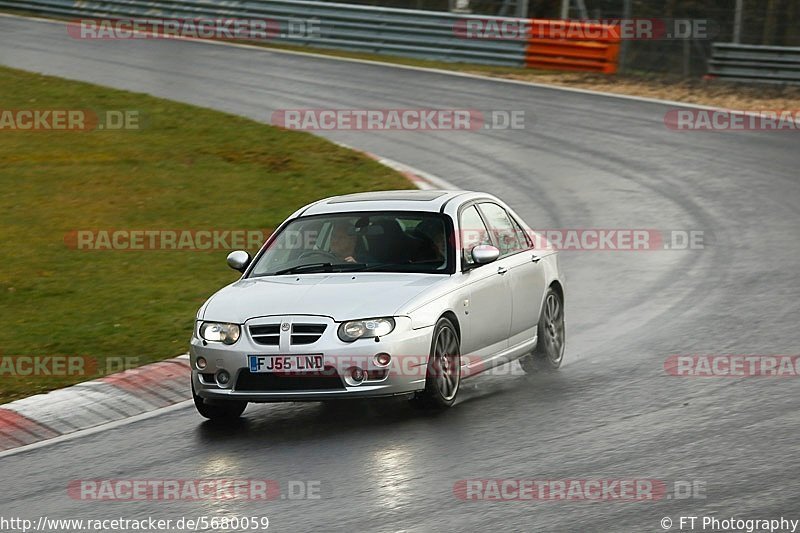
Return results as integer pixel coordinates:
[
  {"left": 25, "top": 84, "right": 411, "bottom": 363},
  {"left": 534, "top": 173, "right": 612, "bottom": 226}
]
[{"left": 0, "top": 13, "right": 726, "bottom": 110}]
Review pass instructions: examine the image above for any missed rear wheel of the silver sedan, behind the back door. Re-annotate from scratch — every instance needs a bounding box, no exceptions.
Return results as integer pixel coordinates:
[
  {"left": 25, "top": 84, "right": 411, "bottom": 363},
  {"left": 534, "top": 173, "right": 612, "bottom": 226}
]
[{"left": 519, "top": 287, "right": 566, "bottom": 374}]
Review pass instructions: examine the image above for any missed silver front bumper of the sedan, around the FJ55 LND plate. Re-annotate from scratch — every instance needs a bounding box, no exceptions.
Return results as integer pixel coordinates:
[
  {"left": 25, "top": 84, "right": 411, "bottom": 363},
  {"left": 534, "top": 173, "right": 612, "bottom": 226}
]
[{"left": 189, "top": 315, "right": 433, "bottom": 402}]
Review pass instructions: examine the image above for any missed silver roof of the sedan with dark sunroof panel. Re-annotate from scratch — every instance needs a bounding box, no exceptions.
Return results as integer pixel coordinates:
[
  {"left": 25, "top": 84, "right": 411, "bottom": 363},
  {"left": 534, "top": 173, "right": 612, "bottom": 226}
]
[{"left": 298, "top": 189, "right": 475, "bottom": 216}]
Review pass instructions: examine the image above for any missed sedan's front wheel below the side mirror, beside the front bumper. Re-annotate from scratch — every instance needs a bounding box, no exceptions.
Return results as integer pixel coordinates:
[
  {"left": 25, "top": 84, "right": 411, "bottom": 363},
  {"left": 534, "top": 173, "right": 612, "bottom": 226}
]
[{"left": 412, "top": 318, "right": 461, "bottom": 409}]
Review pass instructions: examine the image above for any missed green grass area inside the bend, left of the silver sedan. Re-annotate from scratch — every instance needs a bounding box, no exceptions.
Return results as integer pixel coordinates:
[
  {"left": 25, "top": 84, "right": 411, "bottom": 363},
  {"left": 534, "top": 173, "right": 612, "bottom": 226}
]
[{"left": 0, "top": 64, "right": 410, "bottom": 403}]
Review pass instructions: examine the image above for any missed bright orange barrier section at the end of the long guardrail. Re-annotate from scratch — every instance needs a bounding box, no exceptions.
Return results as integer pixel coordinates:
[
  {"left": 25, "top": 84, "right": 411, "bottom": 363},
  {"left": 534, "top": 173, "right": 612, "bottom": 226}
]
[{"left": 525, "top": 19, "right": 620, "bottom": 74}]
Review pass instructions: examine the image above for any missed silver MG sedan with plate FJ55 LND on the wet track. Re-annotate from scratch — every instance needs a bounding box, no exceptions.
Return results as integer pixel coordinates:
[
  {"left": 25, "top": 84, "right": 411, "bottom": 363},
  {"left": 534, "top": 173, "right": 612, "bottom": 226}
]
[{"left": 190, "top": 191, "right": 565, "bottom": 420}]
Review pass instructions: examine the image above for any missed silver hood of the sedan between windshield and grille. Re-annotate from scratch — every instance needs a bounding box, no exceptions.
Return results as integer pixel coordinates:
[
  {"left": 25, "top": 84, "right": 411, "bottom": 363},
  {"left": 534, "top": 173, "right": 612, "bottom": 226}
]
[{"left": 202, "top": 273, "right": 448, "bottom": 324}]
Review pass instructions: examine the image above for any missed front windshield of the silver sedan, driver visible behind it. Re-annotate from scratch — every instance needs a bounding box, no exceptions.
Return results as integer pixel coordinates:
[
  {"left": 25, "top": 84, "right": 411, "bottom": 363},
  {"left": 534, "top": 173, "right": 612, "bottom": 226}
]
[{"left": 250, "top": 211, "right": 455, "bottom": 277}]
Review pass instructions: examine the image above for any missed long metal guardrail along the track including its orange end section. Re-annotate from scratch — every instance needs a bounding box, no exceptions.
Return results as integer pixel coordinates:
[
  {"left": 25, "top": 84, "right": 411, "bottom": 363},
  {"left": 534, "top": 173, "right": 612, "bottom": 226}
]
[{"left": 0, "top": 0, "right": 616, "bottom": 72}]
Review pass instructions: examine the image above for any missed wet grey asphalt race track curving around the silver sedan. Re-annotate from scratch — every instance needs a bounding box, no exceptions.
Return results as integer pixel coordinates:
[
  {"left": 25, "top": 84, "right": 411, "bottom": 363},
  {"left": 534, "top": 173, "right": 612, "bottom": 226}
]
[{"left": 0, "top": 14, "right": 800, "bottom": 531}]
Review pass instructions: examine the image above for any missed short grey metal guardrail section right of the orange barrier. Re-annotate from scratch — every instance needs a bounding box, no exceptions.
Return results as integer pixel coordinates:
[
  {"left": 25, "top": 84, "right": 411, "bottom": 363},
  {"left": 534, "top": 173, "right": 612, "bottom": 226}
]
[{"left": 708, "top": 43, "right": 800, "bottom": 84}]
